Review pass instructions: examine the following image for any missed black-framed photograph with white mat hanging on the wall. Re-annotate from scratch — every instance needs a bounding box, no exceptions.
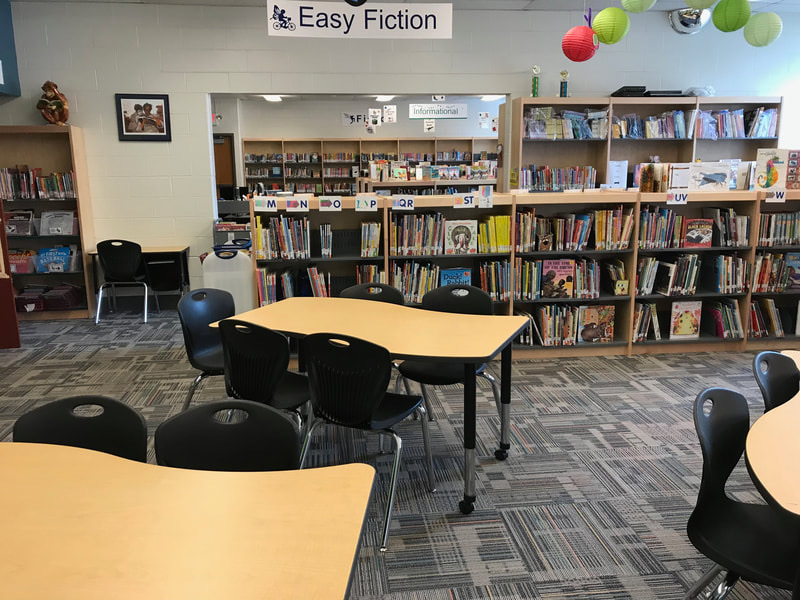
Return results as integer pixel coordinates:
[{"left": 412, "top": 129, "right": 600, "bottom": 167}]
[{"left": 114, "top": 94, "right": 172, "bottom": 142}]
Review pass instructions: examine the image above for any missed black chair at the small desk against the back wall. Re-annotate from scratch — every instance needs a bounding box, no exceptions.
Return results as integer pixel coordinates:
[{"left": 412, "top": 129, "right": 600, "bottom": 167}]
[{"left": 94, "top": 240, "right": 161, "bottom": 324}]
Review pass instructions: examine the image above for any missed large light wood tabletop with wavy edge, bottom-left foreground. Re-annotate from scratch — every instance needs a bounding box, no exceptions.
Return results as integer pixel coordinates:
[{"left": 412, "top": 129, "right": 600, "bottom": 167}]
[{"left": 0, "top": 442, "right": 375, "bottom": 600}]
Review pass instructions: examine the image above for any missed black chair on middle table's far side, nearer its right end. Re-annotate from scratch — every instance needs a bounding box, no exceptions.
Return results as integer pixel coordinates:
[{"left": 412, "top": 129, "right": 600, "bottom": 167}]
[{"left": 397, "top": 284, "right": 501, "bottom": 420}]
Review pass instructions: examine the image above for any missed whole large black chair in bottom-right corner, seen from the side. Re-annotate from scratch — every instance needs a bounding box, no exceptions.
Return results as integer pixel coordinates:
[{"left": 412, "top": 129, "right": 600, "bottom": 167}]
[{"left": 685, "top": 388, "right": 800, "bottom": 600}]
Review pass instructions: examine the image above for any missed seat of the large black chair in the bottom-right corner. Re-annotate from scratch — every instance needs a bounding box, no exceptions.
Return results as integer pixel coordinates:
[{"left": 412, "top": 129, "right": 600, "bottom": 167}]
[{"left": 687, "top": 501, "right": 800, "bottom": 589}]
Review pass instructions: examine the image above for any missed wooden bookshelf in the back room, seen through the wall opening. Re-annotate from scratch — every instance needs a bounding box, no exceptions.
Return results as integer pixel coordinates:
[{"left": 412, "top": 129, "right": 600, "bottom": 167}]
[{"left": 242, "top": 138, "right": 497, "bottom": 195}]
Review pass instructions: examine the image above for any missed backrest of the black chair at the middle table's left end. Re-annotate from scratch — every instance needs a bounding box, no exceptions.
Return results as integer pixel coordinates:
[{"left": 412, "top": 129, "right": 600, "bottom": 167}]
[{"left": 178, "top": 288, "right": 236, "bottom": 371}]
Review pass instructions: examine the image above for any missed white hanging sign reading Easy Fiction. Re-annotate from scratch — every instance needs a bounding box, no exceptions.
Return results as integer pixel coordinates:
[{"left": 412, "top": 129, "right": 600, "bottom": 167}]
[{"left": 267, "top": 0, "right": 453, "bottom": 39}]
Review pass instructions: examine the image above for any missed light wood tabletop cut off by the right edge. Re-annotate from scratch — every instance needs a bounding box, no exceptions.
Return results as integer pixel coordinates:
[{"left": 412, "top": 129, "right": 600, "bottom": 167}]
[{"left": 745, "top": 395, "right": 800, "bottom": 515}]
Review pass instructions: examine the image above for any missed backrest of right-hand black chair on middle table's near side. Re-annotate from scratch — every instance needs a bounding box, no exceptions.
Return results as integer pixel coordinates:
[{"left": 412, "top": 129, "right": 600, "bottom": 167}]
[{"left": 300, "top": 333, "right": 391, "bottom": 429}]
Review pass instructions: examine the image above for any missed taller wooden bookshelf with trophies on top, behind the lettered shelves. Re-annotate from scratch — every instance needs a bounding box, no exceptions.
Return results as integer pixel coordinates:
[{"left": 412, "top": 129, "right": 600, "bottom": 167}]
[{"left": 498, "top": 96, "right": 782, "bottom": 191}]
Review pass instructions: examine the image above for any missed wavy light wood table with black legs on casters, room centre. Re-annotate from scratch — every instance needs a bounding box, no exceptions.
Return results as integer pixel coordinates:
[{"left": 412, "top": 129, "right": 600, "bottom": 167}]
[{"left": 228, "top": 298, "right": 528, "bottom": 514}]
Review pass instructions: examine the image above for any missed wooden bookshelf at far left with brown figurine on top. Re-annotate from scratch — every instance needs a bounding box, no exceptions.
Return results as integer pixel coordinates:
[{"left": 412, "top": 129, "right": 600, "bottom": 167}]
[{"left": 0, "top": 125, "right": 95, "bottom": 320}]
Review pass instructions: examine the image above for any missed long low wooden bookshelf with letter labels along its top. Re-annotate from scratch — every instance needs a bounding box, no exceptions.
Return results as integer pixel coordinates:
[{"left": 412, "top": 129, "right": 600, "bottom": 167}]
[{"left": 251, "top": 190, "right": 800, "bottom": 358}]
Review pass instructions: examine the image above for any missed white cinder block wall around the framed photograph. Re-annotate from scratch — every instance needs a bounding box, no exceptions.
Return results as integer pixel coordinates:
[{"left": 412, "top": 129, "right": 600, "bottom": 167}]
[{"left": 0, "top": 1, "right": 800, "bottom": 286}]
